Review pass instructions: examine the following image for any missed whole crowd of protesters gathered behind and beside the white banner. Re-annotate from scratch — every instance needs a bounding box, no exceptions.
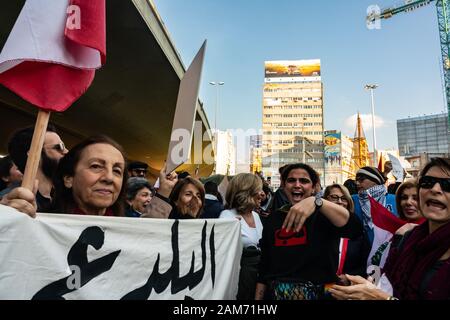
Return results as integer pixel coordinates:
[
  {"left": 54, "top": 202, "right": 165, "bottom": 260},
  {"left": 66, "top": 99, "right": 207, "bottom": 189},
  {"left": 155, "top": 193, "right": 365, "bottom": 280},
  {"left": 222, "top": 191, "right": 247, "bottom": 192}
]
[{"left": 0, "top": 126, "right": 450, "bottom": 300}]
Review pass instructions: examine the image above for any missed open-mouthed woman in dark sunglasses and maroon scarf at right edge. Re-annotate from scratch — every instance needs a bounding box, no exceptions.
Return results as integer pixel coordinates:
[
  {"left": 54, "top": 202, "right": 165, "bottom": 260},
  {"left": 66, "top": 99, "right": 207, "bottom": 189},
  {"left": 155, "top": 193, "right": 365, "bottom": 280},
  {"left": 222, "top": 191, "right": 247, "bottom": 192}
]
[{"left": 330, "top": 158, "right": 450, "bottom": 300}]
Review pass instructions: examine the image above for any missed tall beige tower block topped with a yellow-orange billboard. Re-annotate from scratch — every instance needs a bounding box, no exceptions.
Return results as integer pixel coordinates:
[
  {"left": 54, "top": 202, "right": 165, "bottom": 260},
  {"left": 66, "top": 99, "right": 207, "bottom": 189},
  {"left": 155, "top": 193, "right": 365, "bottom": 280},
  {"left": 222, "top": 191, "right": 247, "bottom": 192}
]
[{"left": 262, "top": 59, "right": 324, "bottom": 187}]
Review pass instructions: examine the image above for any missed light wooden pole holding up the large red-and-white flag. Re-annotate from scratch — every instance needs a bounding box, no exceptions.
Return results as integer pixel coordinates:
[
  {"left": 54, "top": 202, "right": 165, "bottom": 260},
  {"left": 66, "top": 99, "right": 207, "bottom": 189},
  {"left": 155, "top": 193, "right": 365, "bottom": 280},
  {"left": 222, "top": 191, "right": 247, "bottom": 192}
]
[{"left": 22, "top": 109, "right": 50, "bottom": 191}]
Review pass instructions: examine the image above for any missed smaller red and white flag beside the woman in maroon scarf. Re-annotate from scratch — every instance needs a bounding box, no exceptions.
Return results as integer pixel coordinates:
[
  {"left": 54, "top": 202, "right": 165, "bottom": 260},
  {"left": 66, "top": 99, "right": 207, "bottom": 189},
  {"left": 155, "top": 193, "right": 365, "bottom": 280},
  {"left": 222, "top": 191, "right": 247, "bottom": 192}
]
[{"left": 367, "top": 196, "right": 407, "bottom": 269}]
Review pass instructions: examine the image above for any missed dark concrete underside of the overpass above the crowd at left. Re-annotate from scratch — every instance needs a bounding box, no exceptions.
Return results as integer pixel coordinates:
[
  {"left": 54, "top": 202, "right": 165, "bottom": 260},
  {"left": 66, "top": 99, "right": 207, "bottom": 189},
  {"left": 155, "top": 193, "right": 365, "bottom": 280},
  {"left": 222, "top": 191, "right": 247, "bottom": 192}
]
[{"left": 0, "top": 0, "right": 213, "bottom": 180}]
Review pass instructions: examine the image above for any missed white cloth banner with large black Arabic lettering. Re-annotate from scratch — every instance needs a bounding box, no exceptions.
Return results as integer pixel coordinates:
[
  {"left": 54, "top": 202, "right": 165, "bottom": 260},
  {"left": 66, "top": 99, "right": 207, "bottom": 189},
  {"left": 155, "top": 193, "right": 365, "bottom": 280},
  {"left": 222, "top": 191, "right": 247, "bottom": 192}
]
[{"left": 0, "top": 205, "right": 242, "bottom": 300}]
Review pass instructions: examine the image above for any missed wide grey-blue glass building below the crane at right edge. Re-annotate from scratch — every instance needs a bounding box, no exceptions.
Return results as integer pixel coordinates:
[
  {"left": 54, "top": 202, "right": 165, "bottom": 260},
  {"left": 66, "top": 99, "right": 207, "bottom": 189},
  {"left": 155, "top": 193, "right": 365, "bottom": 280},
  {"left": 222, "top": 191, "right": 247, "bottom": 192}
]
[{"left": 397, "top": 113, "right": 449, "bottom": 157}]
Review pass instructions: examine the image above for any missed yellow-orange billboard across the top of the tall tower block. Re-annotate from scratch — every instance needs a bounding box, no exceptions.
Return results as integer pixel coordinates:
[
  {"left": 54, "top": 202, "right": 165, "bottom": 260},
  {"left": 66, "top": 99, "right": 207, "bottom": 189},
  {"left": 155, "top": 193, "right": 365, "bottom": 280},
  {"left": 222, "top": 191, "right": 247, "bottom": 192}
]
[{"left": 265, "top": 59, "right": 321, "bottom": 83}]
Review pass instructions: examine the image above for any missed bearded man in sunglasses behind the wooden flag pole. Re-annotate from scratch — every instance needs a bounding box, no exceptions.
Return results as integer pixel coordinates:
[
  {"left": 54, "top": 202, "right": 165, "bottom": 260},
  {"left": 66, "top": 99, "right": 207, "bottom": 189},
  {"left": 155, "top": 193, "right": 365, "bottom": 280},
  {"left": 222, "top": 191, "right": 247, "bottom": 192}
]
[{"left": 5, "top": 125, "right": 68, "bottom": 212}]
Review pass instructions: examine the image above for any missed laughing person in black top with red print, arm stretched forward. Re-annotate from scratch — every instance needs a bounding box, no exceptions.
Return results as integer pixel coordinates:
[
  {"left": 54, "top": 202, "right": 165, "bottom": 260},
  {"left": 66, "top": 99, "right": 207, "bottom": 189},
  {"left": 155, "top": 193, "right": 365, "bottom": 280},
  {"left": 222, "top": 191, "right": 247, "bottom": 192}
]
[{"left": 255, "top": 163, "right": 362, "bottom": 300}]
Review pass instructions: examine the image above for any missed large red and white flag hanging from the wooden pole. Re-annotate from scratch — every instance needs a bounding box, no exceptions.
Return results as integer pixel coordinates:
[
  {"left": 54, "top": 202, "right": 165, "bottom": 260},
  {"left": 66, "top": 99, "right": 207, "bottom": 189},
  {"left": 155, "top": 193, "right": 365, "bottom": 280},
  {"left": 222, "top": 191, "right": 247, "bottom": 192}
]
[{"left": 0, "top": 0, "right": 106, "bottom": 112}]
